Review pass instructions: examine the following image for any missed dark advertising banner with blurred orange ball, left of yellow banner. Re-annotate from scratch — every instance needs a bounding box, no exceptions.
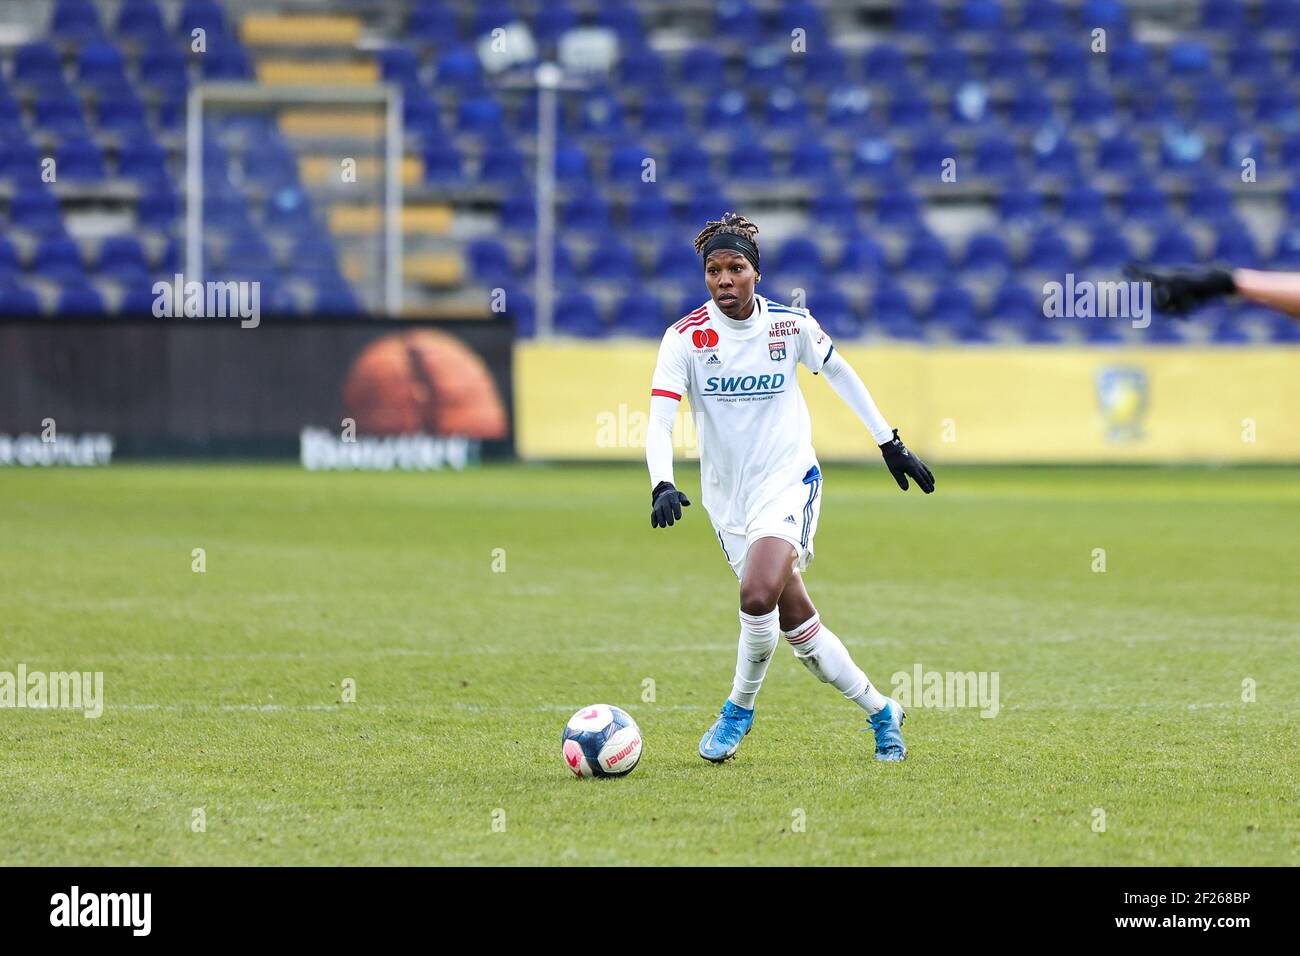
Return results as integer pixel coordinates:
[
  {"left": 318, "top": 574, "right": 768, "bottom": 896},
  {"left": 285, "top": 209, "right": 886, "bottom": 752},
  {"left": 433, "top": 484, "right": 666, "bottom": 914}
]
[{"left": 0, "top": 319, "right": 514, "bottom": 470}]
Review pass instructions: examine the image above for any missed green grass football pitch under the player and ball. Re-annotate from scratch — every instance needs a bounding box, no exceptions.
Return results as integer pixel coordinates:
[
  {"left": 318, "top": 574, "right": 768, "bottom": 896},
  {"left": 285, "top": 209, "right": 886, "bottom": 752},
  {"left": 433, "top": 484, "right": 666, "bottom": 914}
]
[{"left": 0, "top": 464, "right": 1300, "bottom": 865}]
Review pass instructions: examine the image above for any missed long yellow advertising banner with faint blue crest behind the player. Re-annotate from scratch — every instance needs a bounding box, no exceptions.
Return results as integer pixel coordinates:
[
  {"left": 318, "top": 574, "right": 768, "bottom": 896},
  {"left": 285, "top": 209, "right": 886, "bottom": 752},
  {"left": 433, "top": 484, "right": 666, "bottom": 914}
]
[{"left": 515, "top": 341, "right": 1300, "bottom": 463}]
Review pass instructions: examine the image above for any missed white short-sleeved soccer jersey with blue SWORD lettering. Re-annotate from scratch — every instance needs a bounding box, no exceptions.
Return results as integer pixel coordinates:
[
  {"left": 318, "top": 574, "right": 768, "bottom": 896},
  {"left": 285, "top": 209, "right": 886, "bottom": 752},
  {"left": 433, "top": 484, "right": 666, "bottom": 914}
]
[{"left": 651, "top": 295, "right": 833, "bottom": 535}]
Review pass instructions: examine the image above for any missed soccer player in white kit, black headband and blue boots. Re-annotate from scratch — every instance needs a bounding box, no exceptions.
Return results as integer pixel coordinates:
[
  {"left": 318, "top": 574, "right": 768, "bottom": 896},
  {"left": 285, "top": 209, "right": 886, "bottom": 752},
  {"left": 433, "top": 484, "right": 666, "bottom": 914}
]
[{"left": 646, "top": 213, "right": 935, "bottom": 762}]
